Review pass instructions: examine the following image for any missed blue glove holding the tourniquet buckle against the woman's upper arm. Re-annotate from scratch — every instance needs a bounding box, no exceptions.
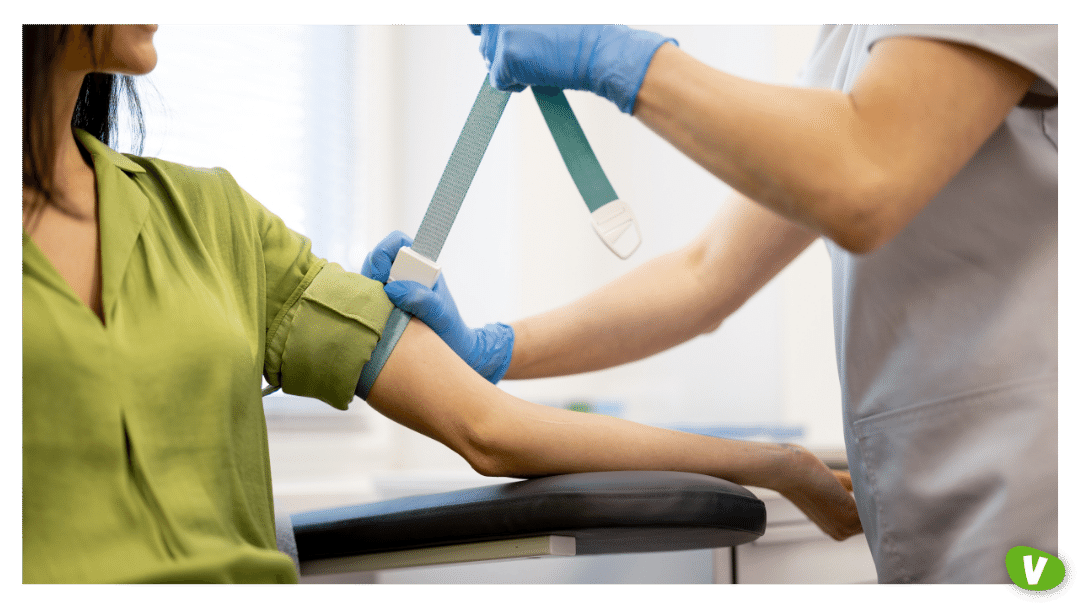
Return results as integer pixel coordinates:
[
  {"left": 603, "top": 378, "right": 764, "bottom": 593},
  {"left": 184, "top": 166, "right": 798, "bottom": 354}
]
[{"left": 360, "top": 230, "right": 514, "bottom": 383}]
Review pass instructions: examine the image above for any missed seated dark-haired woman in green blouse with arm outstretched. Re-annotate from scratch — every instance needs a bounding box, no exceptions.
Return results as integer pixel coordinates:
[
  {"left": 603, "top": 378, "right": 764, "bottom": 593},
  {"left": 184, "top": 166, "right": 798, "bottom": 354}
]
[{"left": 23, "top": 25, "right": 861, "bottom": 583}]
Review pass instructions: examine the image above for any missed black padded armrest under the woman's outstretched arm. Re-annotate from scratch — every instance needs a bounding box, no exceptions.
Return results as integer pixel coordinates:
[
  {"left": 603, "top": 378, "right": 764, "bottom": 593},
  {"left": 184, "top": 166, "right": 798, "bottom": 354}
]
[{"left": 292, "top": 471, "right": 765, "bottom": 562}]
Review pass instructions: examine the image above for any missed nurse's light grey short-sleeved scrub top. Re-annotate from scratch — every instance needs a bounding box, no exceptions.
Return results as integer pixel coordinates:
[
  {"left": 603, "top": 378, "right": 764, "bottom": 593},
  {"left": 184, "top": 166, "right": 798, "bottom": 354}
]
[{"left": 802, "top": 25, "right": 1058, "bottom": 584}]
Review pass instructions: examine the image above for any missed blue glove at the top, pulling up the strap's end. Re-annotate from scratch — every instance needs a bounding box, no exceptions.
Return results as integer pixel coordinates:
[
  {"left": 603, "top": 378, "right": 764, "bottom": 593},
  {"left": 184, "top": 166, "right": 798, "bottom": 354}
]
[{"left": 469, "top": 24, "right": 678, "bottom": 114}]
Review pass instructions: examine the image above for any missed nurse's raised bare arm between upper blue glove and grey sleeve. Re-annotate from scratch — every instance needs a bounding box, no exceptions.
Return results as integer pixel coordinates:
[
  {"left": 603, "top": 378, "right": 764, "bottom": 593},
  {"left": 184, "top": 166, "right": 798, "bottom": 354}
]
[{"left": 634, "top": 38, "right": 1035, "bottom": 253}]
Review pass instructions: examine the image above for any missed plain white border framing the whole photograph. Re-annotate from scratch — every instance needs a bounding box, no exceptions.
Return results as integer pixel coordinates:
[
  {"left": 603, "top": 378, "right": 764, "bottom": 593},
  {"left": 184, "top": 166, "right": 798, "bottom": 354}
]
[{"left": 6, "top": 0, "right": 1080, "bottom": 608}]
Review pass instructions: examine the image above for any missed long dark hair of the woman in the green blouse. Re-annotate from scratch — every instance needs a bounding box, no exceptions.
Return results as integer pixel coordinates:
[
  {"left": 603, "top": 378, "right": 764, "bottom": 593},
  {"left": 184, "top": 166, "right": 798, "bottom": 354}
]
[{"left": 23, "top": 25, "right": 146, "bottom": 212}]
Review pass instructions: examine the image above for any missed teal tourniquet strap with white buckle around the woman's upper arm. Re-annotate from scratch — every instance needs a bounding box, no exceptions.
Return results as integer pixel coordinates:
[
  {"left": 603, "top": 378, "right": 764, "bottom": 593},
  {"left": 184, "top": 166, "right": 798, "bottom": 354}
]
[{"left": 356, "top": 77, "right": 640, "bottom": 398}]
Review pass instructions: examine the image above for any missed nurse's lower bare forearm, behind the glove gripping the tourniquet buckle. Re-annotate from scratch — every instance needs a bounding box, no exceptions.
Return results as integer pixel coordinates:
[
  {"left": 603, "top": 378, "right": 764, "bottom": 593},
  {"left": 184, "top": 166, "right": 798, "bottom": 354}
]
[{"left": 504, "top": 192, "right": 818, "bottom": 379}]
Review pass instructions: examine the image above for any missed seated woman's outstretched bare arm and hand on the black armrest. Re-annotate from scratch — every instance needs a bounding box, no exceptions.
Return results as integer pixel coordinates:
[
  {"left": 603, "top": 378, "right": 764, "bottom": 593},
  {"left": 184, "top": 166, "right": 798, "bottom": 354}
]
[{"left": 367, "top": 320, "right": 862, "bottom": 539}]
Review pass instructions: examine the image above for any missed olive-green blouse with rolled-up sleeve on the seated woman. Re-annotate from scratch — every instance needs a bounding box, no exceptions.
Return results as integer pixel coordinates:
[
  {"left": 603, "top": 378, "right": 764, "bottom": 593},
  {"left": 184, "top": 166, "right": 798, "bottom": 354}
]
[{"left": 23, "top": 132, "right": 392, "bottom": 583}]
